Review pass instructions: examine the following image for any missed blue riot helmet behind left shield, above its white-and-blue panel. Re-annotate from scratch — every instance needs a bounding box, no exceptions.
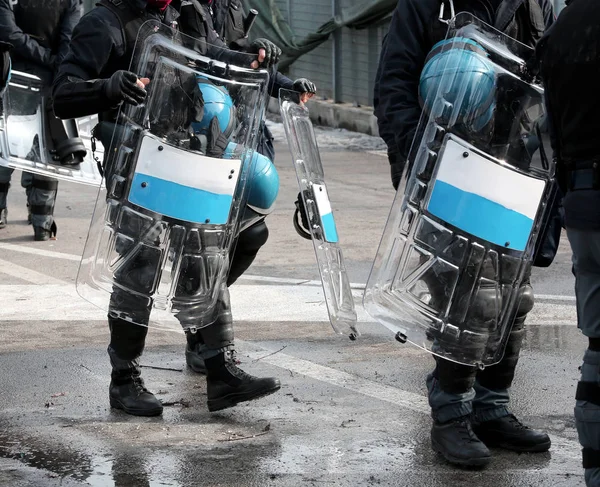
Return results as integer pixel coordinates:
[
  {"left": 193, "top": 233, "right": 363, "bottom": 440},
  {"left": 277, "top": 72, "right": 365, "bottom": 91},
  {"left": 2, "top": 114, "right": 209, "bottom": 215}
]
[{"left": 192, "top": 76, "right": 235, "bottom": 137}]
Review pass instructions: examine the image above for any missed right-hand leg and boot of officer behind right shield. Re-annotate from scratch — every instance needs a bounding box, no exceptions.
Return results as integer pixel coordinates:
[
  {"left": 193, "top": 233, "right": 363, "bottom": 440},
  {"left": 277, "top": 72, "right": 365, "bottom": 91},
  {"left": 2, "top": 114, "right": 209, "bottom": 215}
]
[{"left": 473, "top": 271, "right": 550, "bottom": 452}]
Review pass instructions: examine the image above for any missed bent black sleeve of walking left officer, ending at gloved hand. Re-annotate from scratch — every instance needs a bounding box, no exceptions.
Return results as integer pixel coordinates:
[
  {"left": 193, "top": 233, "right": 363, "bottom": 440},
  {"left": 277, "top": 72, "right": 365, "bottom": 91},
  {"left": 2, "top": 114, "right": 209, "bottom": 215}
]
[{"left": 52, "top": 11, "right": 124, "bottom": 119}]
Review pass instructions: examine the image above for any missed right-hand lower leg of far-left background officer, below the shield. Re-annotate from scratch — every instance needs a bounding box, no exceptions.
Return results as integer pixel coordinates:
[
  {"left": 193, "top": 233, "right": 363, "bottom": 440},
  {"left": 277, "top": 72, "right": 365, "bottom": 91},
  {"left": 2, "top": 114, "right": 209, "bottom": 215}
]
[{"left": 21, "top": 173, "right": 58, "bottom": 241}]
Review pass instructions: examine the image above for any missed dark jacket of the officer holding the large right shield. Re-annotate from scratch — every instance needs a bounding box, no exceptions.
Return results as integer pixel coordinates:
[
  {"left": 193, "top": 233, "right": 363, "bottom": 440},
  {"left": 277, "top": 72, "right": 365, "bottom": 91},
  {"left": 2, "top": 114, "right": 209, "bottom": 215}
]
[{"left": 373, "top": 0, "right": 554, "bottom": 160}]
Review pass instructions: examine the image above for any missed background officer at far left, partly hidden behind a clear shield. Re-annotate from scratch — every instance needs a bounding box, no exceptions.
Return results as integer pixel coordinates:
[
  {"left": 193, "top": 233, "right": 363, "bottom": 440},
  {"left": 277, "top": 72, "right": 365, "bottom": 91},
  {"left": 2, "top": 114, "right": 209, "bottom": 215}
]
[{"left": 0, "top": 0, "right": 81, "bottom": 241}]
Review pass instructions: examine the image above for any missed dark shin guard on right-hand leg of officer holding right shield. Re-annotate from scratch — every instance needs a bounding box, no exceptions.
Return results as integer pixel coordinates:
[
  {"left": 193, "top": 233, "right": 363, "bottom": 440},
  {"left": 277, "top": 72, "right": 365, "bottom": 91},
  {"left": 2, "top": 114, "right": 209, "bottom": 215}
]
[{"left": 477, "top": 283, "right": 534, "bottom": 391}]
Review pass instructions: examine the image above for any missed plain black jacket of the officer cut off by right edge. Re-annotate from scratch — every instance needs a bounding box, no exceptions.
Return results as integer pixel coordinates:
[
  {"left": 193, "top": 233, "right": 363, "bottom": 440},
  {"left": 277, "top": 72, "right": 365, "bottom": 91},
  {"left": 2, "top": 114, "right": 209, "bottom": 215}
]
[{"left": 538, "top": 0, "right": 600, "bottom": 231}]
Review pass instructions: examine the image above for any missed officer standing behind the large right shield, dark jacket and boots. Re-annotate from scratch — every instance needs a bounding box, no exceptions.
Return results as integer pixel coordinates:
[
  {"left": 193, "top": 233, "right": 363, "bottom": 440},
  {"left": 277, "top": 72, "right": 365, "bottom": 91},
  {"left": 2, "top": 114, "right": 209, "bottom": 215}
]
[{"left": 374, "top": 0, "right": 554, "bottom": 466}]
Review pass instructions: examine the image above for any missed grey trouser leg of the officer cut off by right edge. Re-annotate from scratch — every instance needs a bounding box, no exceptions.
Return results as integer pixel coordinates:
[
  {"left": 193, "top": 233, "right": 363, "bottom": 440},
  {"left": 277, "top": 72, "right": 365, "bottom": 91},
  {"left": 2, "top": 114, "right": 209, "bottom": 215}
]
[{"left": 567, "top": 228, "right": 600, "bottom": 487}]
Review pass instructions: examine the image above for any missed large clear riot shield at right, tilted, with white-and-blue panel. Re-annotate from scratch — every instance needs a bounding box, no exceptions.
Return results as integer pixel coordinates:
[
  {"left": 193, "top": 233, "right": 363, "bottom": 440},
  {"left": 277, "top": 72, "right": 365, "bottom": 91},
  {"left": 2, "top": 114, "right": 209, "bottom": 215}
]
[{"left": 363, "top": 14, "right": 553, "bottom": 366}]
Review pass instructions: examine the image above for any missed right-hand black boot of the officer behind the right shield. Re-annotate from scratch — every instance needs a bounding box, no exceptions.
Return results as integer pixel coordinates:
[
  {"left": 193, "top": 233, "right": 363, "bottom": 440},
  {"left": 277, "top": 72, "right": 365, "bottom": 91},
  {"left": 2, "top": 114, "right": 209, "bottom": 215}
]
[{"left": 473, "top": 414, "right": 551, "bottom": 453}]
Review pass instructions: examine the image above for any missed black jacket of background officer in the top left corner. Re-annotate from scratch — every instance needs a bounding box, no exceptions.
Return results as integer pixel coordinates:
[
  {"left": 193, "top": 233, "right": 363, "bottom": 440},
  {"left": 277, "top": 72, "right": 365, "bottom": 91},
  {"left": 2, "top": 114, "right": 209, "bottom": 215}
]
[{"left": 0, "top": 0, "right": 81, "bottom": 81}]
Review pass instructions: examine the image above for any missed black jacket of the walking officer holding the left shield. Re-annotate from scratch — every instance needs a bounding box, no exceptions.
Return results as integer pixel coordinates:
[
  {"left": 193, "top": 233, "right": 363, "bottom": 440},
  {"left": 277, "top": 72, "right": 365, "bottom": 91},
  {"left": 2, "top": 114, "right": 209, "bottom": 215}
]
[{"left": 53, "top": 0, "right": 179, "bottom": 120}]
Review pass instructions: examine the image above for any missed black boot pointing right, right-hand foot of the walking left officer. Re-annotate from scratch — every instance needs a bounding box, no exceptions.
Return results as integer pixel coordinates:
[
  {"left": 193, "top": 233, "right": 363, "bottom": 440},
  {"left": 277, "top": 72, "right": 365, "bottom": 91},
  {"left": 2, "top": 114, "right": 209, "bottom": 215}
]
[{"left": 205, "top": 352, "right": 281, "bottom": 411}]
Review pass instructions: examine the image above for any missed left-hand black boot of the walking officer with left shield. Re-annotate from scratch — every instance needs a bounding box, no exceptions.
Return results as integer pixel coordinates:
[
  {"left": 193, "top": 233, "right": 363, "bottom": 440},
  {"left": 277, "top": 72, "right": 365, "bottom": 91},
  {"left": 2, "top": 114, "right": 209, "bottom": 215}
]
[{"left": 108, "top": 349, "right": 163, "bottom": 416}]
